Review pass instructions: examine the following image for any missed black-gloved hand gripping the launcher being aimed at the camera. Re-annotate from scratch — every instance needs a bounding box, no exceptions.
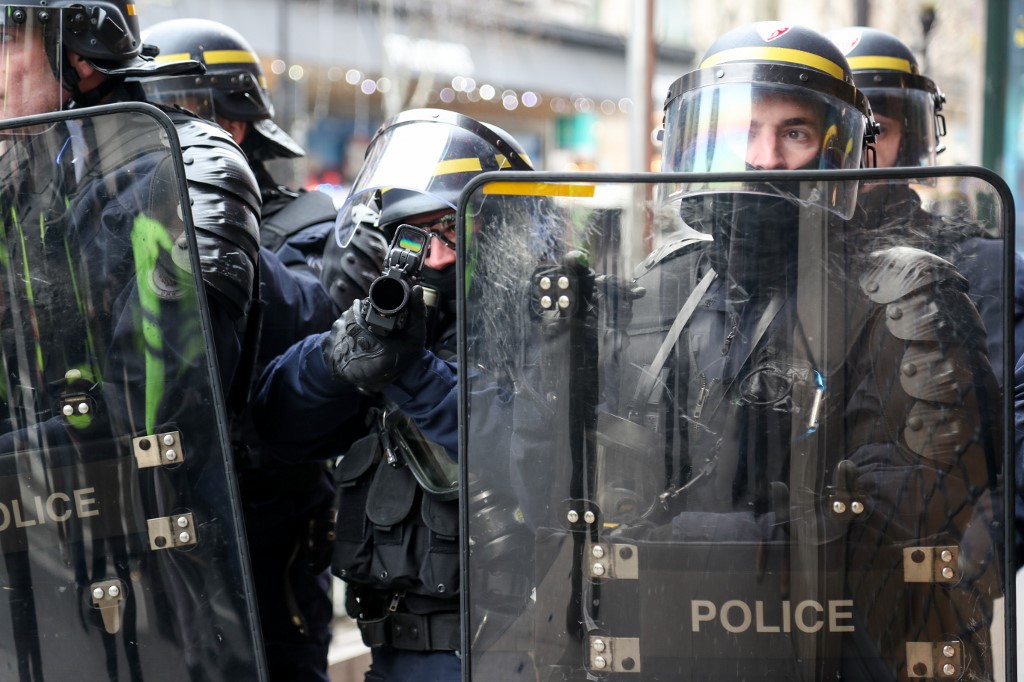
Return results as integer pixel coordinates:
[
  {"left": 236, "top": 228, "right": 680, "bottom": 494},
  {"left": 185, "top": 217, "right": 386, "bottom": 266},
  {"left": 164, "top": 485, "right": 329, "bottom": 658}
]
[{"left": 323, "top": 286, "right": 427, "bottom": 390}]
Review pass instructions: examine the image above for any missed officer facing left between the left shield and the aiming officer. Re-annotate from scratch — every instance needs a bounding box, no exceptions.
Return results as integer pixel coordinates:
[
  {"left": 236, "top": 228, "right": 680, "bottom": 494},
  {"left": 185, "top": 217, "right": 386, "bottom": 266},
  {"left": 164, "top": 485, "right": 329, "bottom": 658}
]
[{"left": 142, "top": 18, "right": 386, "bottom": 682}]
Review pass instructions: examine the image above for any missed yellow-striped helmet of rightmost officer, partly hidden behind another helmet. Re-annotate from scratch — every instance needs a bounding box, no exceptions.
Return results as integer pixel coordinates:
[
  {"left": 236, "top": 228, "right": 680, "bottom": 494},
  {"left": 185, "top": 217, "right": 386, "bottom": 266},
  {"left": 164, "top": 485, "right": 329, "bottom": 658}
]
[{"left": 828, "top": 27, "right": 946, "bottom": 166}]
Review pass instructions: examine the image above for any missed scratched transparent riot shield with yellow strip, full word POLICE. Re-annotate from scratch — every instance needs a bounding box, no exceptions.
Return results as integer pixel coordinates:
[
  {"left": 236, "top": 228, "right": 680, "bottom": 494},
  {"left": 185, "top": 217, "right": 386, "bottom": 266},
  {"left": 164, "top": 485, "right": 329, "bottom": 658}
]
[{"left": 459, "top": 168, "right": 1019, "bottom": 682}]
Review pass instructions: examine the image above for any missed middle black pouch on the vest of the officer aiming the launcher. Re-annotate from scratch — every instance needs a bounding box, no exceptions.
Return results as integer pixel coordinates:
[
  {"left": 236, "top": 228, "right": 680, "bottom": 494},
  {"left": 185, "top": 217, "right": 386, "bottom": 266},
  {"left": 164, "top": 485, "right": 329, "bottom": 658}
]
[{"left": 366, "top": 462, "right": 423, "bottom": 590}]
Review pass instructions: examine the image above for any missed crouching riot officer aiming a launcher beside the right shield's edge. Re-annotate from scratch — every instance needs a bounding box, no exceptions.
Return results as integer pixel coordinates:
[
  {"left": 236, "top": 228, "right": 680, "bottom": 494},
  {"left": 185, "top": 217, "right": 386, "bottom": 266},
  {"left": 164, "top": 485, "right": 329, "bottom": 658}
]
[{"left": 254, "top": 110, "right": 529, "bottom": 680}]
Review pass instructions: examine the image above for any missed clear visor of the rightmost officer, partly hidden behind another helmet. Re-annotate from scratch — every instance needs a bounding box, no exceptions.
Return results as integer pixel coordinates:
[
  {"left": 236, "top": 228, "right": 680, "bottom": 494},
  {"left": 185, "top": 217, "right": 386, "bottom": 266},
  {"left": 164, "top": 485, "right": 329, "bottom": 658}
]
[{"left": 863, "top": 88, "right": 939, "bottom": 168}]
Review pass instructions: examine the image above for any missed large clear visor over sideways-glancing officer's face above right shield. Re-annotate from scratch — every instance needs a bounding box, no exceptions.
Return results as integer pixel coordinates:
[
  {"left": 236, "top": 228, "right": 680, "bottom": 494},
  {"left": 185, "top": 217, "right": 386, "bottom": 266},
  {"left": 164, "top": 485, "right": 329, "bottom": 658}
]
[{"left": 662, "top": 83, "right": 866, "bottom": 217}]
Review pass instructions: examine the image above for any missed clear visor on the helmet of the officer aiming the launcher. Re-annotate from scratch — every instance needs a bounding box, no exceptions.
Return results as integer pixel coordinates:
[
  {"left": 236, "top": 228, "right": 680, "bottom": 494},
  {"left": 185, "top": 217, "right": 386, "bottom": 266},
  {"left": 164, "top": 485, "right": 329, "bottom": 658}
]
[{"left": 335, "top": 121, "right": 495, "bottom": 246}]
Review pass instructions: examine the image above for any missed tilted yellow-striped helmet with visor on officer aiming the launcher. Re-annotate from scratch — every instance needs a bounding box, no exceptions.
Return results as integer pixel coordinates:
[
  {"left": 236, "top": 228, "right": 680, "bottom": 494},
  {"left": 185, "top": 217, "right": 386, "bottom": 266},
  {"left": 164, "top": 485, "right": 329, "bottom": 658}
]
[{"left": 336, "top": 109, "right": 532, "bottom": 246}]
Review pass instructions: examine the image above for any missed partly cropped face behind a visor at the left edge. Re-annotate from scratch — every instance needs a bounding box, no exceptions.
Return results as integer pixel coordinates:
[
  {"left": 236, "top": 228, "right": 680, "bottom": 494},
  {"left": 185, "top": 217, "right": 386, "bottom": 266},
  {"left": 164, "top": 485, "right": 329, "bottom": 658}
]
[{"left": 0, "top": 26, "right": 63, "bottom": 120}]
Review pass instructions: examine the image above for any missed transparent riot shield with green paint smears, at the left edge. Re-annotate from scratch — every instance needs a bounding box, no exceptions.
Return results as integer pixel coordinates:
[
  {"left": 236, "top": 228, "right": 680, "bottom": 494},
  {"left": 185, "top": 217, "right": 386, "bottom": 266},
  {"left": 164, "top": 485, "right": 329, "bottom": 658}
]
[{"left": 0, "top": 104, "right": 263, "bottom": 682}]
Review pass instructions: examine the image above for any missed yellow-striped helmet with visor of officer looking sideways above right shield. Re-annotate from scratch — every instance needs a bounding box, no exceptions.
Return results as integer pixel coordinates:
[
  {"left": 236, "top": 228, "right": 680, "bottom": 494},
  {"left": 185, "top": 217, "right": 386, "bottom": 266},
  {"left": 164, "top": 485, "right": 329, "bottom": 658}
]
[{"left": 662, "top": 22, "right": 874, "bottom": 217}]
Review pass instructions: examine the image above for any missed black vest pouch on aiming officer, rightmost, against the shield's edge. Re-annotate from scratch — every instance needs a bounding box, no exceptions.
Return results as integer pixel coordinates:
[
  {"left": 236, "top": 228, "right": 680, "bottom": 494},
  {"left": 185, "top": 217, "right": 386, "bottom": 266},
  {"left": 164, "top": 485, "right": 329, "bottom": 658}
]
[{"left": 420, "top": 494, "right": 460, "bottom": 597}]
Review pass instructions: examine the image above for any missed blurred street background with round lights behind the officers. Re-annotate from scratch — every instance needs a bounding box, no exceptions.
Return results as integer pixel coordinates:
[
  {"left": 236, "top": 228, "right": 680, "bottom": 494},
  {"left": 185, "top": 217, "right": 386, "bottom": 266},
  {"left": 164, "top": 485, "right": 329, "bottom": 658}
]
[{"left": 137, "top": 0, "right": 1024, "bottom": 682}]
